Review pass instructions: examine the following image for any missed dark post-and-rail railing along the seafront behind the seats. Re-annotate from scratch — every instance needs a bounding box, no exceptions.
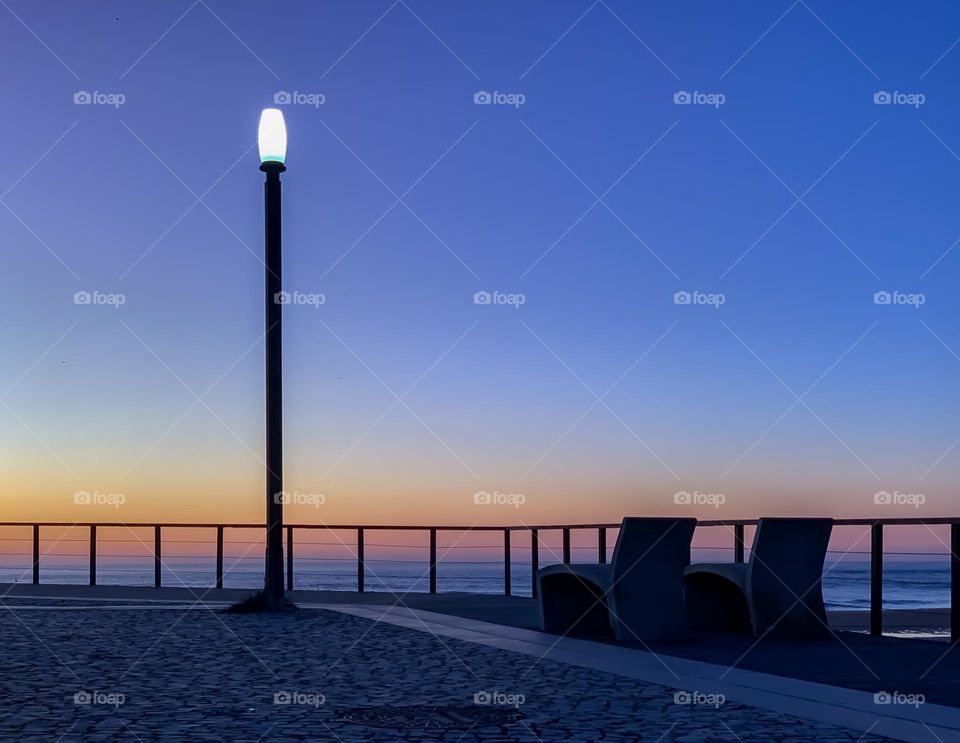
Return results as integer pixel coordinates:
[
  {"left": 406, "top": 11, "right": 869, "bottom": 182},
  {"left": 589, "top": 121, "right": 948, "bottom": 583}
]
[{"left": 0, "top": 517, "right": 960, "bottom": 643}]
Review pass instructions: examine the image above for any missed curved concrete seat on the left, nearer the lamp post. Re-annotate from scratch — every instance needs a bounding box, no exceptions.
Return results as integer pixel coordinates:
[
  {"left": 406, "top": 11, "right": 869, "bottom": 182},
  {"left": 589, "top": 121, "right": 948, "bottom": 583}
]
[{"left": 537, "top": 518, "right": 697, "bottom": 642}]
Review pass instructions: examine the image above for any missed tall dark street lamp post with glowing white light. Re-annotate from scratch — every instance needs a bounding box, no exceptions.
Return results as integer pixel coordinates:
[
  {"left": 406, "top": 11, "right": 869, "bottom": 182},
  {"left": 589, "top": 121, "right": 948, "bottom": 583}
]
[{"left": 257, "top": 108, "right": 287, "bottom": 611}]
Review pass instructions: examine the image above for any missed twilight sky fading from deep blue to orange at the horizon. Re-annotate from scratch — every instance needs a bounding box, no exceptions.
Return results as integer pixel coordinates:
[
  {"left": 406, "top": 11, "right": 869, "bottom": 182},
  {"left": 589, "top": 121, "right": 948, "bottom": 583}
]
[{"left": 0, "top": 0, "right": 960, "bottom": 536}]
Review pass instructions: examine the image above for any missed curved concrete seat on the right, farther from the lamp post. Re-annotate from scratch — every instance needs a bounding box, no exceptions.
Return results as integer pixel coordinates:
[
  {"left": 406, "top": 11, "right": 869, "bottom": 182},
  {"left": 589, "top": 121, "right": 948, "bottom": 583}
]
[{"left": 684, "top": 518, "right": 833, "bottom": 639}]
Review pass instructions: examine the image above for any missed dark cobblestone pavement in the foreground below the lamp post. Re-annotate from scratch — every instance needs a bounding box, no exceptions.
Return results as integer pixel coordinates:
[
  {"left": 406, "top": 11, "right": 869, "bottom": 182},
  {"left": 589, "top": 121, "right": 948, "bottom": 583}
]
[{"left": 0, "top": 597, "right": 896, "bottom": 743}]
